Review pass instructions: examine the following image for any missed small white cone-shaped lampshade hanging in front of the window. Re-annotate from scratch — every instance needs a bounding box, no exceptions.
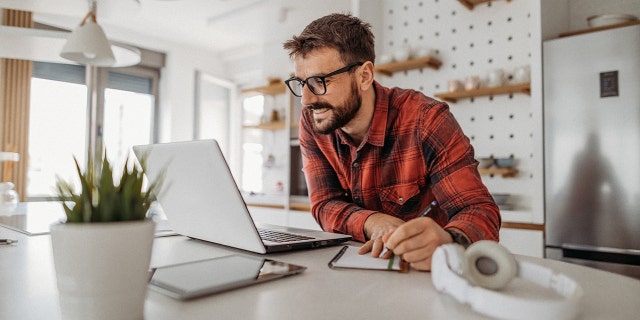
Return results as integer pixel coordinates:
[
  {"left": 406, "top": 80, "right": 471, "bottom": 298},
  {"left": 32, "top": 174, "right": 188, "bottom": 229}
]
[{"left": 60, "top": 19, "right": 116, "bottom": 67}]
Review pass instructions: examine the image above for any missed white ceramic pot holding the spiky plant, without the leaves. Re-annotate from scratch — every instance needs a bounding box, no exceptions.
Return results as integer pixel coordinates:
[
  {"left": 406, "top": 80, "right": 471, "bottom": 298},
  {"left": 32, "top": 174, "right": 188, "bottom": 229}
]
[{"left": 51, "top": 220, "right": 155, "bottom": 320}]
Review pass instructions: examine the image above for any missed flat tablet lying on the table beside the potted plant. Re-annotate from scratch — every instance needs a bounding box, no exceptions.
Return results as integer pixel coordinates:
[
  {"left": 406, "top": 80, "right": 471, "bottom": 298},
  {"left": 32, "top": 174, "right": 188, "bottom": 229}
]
[{"left": 149, "top": 255, "right": 306, "bottom": 300}]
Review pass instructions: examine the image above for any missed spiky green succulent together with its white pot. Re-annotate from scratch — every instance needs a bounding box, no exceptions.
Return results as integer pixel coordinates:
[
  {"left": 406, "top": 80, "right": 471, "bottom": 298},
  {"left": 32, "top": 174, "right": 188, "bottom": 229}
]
[{"left": 51, "top": 155, "right": 159, "bottom": 319}]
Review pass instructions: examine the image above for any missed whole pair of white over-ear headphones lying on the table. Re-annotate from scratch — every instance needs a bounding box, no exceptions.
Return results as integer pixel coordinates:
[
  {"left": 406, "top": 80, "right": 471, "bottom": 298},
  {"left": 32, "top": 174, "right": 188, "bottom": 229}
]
[{"left": 431, "top": 240, "right": 582, "bottom": 319}]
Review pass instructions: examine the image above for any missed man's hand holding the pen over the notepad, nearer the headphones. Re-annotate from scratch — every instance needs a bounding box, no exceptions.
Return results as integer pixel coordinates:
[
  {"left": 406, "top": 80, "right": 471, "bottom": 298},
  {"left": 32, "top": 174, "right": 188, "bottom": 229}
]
[{"left": 382, "top": 217, "right": 453, "bottom": 271}]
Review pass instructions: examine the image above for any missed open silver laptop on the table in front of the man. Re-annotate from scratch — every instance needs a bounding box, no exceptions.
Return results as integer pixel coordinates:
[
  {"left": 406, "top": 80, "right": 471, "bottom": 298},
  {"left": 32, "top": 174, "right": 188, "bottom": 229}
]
[{"left": 133, "top": 140, "right": 351, "bottom": 253}]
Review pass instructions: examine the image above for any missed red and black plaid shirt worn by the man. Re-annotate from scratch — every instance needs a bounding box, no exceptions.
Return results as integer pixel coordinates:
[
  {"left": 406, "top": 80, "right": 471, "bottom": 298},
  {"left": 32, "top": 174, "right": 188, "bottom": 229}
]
[{"left": 300, "top": 82, "right": 501, "bottom": 242}]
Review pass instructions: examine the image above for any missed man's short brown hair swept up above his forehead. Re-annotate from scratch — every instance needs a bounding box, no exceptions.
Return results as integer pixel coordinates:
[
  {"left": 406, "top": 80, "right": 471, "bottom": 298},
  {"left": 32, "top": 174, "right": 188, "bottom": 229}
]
[{"left": 283, "top": 13, "right": 376, "bottom": 64}]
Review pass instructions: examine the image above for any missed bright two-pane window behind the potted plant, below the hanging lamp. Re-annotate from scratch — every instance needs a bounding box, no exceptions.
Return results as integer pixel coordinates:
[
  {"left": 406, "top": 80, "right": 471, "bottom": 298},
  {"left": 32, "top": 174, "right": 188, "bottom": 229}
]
[{"left": 26, "top": 62, "right": 159, "bottom": 201}]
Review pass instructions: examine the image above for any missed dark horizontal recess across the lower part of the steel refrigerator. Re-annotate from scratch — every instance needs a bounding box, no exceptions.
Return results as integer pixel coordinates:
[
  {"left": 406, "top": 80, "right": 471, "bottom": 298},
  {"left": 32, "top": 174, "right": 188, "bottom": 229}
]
[{"left": 560, "top": 243, "right": 640, "bottom": 266}]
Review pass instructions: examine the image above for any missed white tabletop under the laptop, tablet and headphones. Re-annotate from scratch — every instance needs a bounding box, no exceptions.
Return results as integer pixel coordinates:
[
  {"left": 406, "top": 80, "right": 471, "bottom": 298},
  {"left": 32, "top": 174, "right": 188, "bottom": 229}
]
[{"left": 0, "top": 209, "right": 640, "bottom": 320}]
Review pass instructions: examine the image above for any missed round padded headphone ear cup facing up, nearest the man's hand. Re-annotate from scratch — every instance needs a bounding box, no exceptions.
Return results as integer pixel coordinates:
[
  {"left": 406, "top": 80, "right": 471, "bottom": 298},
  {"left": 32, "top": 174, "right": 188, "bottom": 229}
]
[{"left": 464, "top": 240, "right": 518, "bottom": 290}]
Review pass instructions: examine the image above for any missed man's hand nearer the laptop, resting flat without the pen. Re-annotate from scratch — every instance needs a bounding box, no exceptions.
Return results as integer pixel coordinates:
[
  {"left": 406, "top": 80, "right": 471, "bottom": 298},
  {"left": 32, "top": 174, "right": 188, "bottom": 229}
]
[{"left": 358, "top": 213, "right": 404, "bottom": 258}]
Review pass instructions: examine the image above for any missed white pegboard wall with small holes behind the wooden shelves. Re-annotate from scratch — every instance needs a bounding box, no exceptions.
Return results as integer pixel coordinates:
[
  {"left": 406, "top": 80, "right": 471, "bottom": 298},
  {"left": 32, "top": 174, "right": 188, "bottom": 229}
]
[{"left": 376, "top": 0, "right": 543, "bottom": 222}]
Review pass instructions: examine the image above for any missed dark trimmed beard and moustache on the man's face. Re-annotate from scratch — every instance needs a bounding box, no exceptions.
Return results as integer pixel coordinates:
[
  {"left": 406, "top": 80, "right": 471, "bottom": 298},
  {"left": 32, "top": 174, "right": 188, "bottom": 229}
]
[{"left": 306, "top": 81, "right": 362, "bottom": 134}]
